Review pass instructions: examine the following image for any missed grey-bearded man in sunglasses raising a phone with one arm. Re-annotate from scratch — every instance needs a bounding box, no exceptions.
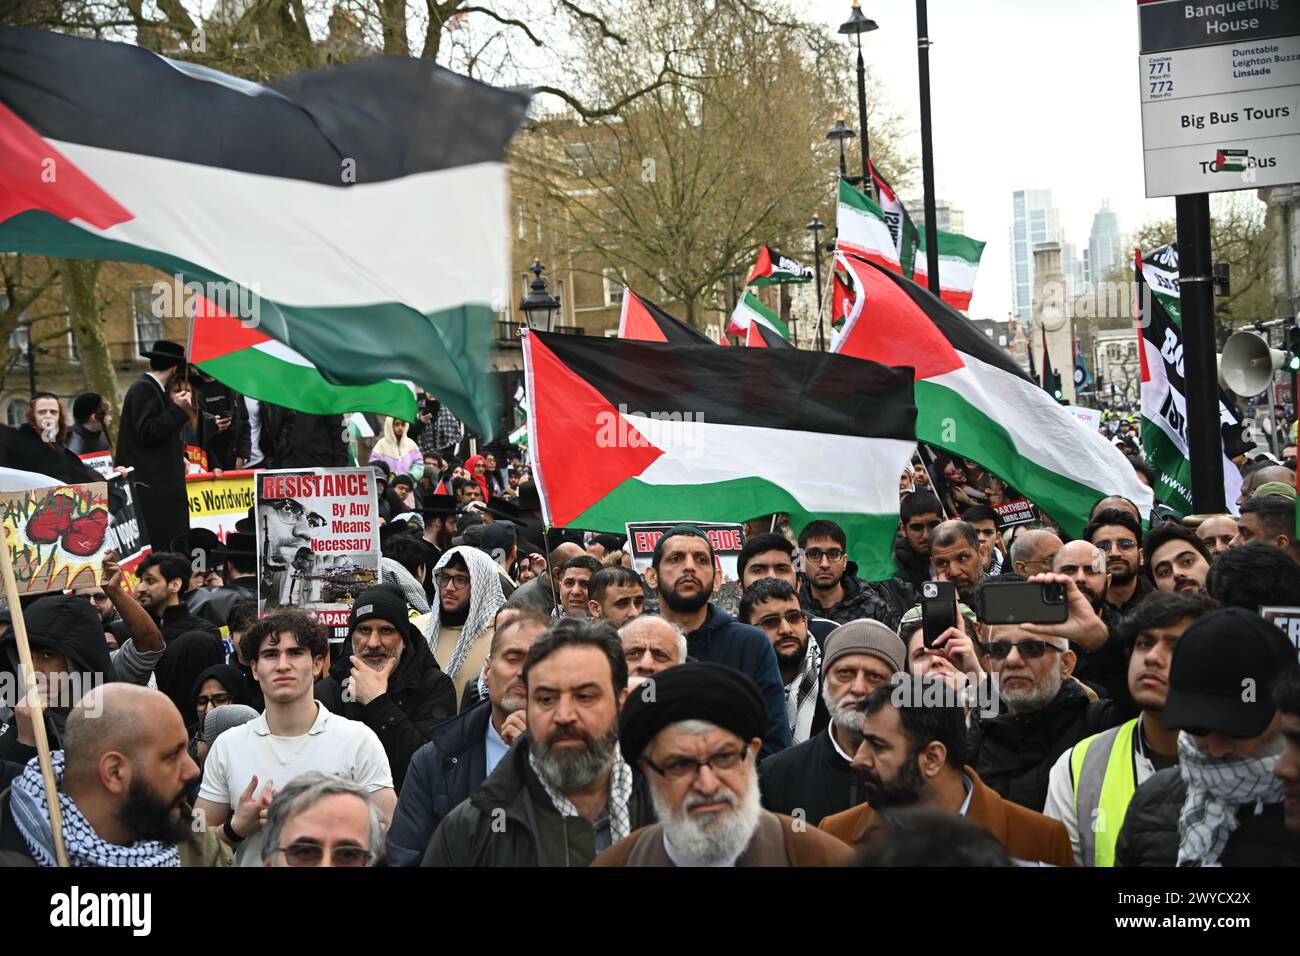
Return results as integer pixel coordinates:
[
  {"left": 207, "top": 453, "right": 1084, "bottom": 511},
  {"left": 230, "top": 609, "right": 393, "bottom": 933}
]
[{"left": 970, "top": 574, "right": 1138, "bottom": 813}]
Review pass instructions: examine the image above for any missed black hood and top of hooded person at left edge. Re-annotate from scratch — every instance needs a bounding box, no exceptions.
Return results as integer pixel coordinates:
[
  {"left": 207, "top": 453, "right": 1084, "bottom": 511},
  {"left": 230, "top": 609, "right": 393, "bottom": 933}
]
[{"left": 0, "top": 594, "right": 117, "bottom": 763}]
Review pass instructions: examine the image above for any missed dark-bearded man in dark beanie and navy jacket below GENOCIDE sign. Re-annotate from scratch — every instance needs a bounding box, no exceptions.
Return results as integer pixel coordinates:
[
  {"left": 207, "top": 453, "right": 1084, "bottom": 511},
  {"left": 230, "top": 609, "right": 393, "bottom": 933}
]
[{"left": 645, "top": 524, "right": 790, "bottom": 757}]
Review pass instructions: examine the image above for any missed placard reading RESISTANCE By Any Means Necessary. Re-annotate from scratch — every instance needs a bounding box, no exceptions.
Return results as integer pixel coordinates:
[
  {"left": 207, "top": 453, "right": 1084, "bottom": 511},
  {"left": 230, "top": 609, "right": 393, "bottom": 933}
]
[{"left": 254, "top": 468, "right": 380, "bottom": 627}]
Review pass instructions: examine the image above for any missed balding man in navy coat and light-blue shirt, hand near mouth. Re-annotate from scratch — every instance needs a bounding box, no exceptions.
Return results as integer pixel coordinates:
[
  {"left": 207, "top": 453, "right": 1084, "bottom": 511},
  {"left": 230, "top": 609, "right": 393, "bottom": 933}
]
[{"left": 389, "top": 611, "right": 549, "bottom": 866}]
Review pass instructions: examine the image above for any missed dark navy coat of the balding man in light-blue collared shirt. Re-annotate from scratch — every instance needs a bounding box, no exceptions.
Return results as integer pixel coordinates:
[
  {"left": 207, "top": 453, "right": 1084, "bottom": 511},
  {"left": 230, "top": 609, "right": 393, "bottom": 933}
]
[{"left": 389, "top": 702, "right": 491, "bottom": 866}]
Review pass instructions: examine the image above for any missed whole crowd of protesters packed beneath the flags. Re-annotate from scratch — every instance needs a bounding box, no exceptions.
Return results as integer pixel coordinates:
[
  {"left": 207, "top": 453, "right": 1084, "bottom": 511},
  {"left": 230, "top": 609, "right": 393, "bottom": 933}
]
[{"left": 0, "top": 342, "right": 1300, "bottom": 868}]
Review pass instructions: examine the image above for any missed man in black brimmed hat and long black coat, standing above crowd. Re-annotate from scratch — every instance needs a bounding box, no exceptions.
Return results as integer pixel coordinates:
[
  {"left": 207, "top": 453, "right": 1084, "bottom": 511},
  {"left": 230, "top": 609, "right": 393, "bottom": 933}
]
[{"left": 113, "top": 339, "right": 194, "bottom": 556}]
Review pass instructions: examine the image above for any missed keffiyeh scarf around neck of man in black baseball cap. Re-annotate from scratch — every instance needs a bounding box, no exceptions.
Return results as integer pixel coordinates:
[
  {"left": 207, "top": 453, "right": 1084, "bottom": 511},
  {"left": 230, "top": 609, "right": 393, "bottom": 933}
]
[{"left": 1178, "top": 734, "right": 1284, "bottom": 866}]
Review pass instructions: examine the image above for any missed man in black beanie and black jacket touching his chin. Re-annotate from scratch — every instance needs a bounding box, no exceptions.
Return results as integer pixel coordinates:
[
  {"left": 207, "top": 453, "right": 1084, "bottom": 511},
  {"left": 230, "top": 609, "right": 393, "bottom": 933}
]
[{"left": 316, "top": 584, "right": 456, "bottom": 791}]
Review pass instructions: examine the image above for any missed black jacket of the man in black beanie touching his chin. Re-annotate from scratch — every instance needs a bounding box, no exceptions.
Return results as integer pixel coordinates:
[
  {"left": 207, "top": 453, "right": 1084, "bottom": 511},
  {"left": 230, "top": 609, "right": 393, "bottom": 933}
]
[{"left": 316, "top": 623, "right": 456, "bottom": 791}]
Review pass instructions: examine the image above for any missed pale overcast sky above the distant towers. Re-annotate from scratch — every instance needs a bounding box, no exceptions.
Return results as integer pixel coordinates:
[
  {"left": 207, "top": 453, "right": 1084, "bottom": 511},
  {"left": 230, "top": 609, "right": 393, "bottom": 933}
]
[{"left": 809, "top": 0, "right": 1190, "bottom": 319}]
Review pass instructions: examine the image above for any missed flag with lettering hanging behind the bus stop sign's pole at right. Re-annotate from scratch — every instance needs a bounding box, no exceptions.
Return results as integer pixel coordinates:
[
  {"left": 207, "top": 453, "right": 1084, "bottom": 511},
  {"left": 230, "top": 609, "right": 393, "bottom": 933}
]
[{"left": 1134, "top": 247, "right": 1242, "bottom": 516}]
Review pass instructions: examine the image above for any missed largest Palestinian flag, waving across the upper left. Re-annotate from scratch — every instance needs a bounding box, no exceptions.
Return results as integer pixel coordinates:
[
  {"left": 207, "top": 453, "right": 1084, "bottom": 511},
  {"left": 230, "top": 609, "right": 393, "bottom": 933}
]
[{"left": 0, "top": 29, "right": 528, "bottom": 434}]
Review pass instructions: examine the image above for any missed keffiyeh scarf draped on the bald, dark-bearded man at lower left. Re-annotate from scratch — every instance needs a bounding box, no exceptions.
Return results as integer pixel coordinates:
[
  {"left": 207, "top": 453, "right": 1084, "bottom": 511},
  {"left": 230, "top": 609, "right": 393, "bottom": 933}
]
[{"left": 9, "top": 750, "right": 181, "bottom": 866}]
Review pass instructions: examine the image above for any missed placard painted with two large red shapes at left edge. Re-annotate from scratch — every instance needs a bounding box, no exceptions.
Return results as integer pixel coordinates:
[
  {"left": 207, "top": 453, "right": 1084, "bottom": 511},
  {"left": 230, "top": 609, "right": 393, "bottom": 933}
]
[{"left": 0, "top": 481, "right": 109, "bottom": 594}]
